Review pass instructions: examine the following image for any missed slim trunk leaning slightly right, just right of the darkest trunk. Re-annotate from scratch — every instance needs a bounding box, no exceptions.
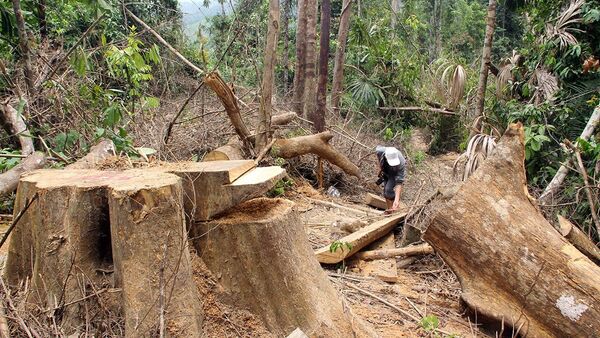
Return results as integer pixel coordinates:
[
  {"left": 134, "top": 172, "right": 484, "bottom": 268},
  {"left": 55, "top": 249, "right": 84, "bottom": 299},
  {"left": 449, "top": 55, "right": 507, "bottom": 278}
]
[{"left": 331, "top": 0, "right": 352, "bottom": 113}]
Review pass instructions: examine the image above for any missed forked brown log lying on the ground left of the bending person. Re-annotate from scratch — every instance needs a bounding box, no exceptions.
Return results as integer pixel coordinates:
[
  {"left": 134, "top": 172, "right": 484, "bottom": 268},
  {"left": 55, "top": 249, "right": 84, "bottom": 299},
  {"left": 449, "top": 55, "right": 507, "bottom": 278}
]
[{"left": 272, "top": 131, "right": 361, "bottom": 178}]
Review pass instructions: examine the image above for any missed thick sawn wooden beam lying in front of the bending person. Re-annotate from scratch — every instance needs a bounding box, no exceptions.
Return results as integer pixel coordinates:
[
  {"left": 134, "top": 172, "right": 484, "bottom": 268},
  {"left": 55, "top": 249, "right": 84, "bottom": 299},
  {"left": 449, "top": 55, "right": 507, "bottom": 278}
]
[{"left": 315, "top": 212, "right": 406, "bottom": 264}]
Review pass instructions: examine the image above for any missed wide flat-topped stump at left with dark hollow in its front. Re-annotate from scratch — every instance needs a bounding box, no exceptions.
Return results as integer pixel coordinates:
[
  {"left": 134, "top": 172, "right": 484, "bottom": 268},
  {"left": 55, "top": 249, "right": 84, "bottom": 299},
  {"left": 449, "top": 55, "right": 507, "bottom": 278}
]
[{"left": 5, "top": 169, "right": 202, "bottom": 337}]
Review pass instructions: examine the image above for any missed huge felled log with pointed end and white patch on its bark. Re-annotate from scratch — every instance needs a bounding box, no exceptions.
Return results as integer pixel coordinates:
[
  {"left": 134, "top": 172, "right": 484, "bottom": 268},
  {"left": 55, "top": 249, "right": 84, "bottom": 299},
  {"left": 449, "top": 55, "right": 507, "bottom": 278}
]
[{"left": 424, "top": 124, "right": 600, "bottom": 337}]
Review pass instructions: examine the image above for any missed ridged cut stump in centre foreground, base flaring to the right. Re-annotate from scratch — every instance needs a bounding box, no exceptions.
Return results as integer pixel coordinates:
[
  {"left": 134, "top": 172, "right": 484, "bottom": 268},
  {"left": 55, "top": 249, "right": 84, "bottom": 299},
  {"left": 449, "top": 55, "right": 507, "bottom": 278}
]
[{"left": 191, "top": 198, "right": 372, "bottom": 337}]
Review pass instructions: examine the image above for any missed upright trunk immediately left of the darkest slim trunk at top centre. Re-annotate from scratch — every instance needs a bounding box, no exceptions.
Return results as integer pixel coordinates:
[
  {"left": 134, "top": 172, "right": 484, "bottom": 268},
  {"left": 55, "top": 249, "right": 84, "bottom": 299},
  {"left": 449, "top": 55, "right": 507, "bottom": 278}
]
[{"left": 304, "top": 0, "right": 318, "bottom": 117}]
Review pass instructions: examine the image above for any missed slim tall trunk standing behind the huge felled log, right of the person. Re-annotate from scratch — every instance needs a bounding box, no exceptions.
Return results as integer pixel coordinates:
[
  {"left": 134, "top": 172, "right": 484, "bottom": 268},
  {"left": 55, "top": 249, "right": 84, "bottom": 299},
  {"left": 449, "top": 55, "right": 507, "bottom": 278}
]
[{"left": 469, "top": 0, "right": 496, "bottom": 138}]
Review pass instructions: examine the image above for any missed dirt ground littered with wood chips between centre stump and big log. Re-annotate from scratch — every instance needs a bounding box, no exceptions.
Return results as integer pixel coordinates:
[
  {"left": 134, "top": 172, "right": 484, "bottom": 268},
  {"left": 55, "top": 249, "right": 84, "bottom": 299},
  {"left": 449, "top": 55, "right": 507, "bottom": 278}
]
[{"left": 278, "top": 154, "right": 487, "bottom": 337}]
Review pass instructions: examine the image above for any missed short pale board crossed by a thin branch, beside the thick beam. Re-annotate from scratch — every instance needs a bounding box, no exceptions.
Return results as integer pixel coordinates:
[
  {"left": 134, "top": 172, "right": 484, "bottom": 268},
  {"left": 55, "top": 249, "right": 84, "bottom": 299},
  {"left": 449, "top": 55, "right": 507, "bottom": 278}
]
[{"left": 353, "top": 233, "right": 398, "bottom": 283}]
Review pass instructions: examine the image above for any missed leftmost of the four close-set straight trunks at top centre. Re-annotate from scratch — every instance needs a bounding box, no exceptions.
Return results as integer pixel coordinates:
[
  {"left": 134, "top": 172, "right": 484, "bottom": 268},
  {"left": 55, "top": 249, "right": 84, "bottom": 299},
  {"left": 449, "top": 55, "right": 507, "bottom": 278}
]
[{"left": 293, "top": 0, "right": 309, "bottom": 115}]
